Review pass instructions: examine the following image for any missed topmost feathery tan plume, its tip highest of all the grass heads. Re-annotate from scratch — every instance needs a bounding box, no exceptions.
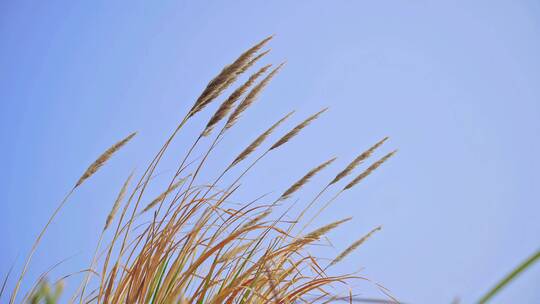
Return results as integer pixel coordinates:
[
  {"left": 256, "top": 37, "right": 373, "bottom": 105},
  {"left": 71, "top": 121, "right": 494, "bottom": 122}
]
[{"left": 189, "top": 36, "right": 273, "bottom": 117}]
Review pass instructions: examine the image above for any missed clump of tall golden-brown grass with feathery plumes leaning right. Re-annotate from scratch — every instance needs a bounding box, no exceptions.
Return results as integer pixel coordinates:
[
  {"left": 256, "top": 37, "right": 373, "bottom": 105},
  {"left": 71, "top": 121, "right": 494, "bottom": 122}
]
[{"left": 0, "top": 37, "right": 395, "bottom": 304}]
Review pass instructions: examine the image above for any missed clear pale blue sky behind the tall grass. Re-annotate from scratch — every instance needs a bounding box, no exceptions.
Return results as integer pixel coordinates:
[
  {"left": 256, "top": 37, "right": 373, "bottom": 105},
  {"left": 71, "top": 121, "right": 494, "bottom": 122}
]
[{"left": 0, "top": 0, "right": 540, "bottom": 303}]
